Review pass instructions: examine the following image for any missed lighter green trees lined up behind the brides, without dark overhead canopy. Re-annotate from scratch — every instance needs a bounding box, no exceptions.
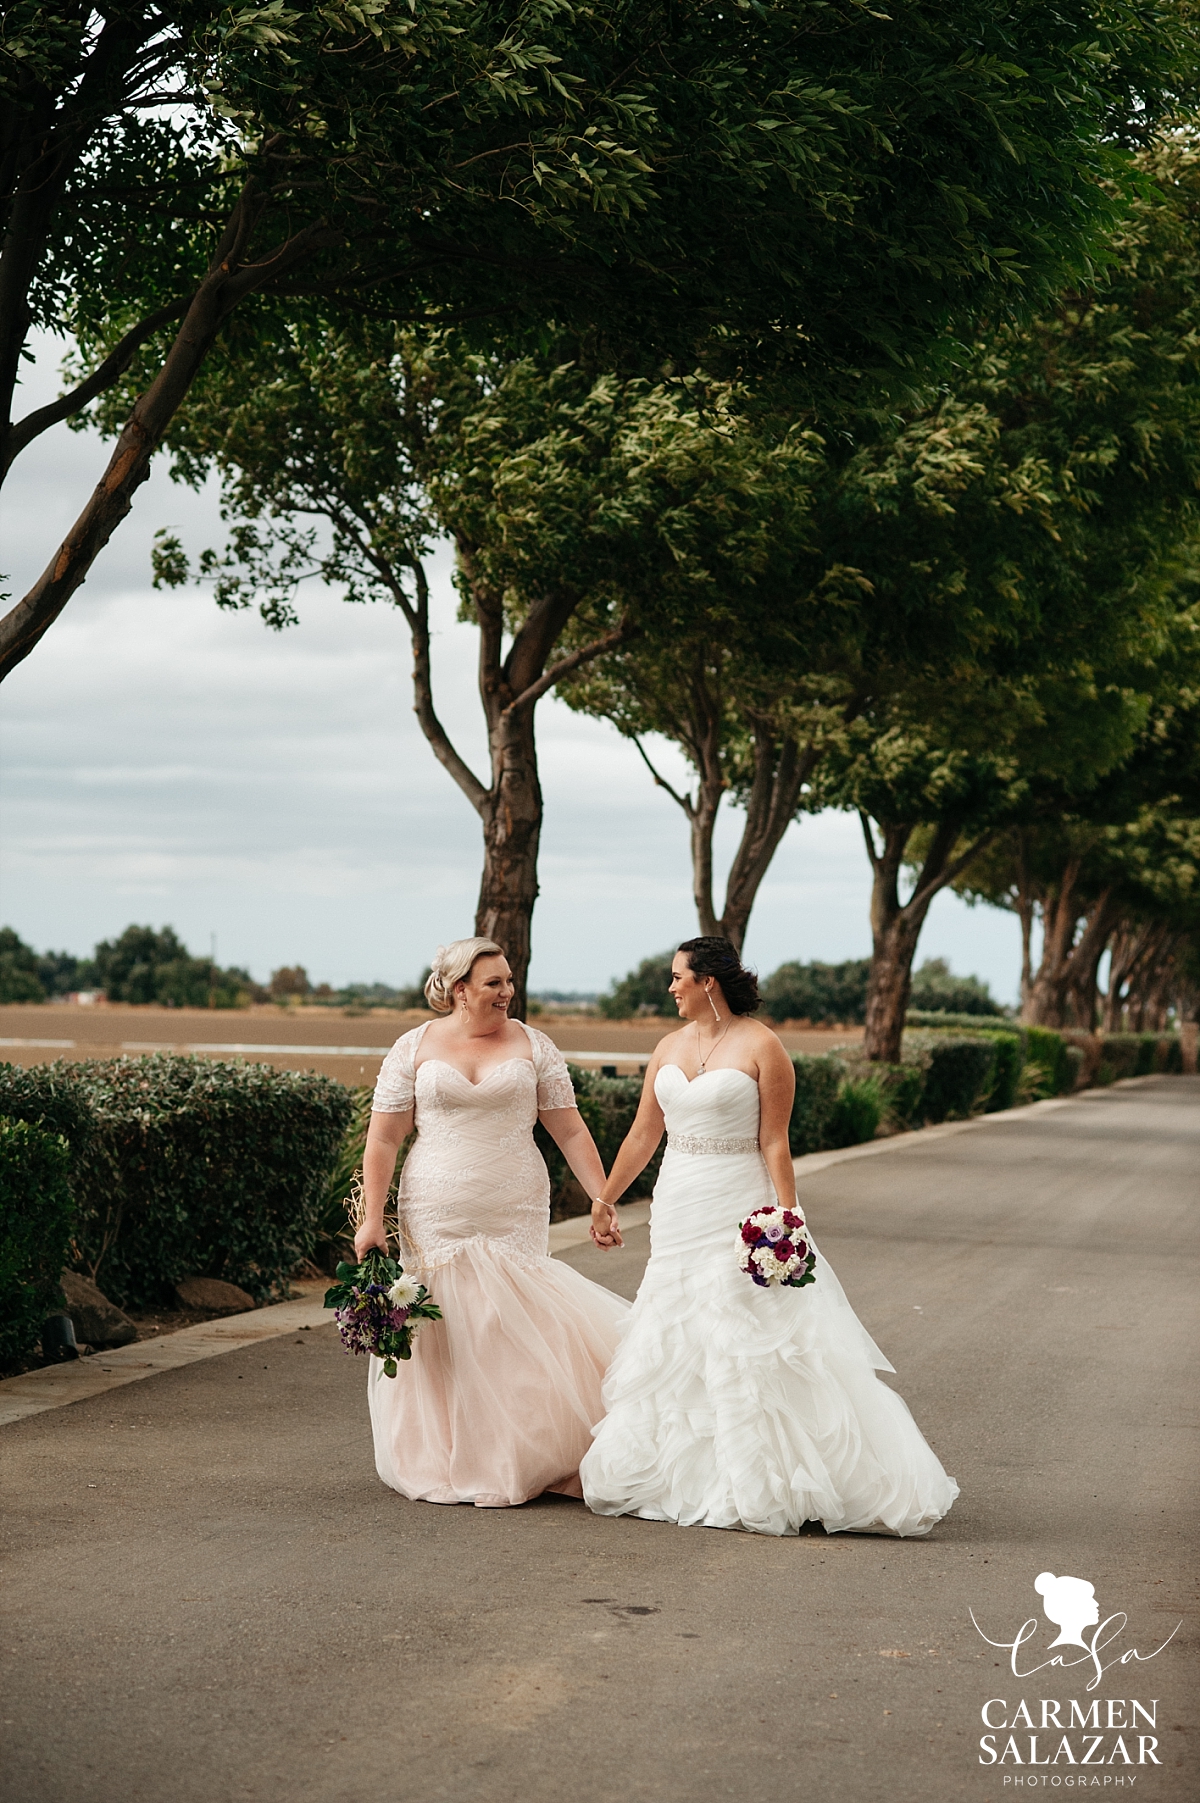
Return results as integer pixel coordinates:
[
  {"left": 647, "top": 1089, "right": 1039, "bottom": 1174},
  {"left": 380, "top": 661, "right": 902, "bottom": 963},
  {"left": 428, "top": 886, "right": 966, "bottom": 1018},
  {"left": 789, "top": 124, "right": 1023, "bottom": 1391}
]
[{"left": 149, "top": 139, "right": 1200, "bottom": 1060}]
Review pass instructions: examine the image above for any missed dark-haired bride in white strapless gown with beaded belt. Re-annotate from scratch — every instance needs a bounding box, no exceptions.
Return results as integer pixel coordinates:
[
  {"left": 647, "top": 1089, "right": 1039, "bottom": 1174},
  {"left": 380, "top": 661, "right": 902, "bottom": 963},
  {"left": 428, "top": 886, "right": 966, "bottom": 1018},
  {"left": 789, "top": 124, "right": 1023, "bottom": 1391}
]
[{"left": 580, "top": 938, "right": 959, "bottom": 1534}]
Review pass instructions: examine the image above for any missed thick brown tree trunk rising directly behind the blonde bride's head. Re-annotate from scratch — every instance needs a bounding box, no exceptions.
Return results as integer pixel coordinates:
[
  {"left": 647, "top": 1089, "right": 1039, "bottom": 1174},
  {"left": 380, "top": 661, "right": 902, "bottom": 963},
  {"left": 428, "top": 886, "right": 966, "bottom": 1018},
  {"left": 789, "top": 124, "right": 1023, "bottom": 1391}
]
[{"left": 476, "top": 707, "right": 542, "bottom": 1020}]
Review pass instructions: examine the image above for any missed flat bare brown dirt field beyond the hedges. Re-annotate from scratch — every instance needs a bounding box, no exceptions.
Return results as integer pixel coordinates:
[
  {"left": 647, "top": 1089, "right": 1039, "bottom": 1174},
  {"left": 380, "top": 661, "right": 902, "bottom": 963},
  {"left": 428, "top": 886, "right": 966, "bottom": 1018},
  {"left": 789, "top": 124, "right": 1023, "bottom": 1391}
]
[{"left": 0, "top": 1002, "right": 863, "bottom": 1084}]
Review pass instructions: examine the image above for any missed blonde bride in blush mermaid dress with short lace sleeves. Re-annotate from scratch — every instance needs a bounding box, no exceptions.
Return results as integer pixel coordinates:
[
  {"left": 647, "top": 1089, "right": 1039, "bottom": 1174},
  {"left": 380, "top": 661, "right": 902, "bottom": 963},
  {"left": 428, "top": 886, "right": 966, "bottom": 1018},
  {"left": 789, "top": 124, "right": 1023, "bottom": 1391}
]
[{"left": 355, "top": 939, "right": 629, "bottom": 1509}]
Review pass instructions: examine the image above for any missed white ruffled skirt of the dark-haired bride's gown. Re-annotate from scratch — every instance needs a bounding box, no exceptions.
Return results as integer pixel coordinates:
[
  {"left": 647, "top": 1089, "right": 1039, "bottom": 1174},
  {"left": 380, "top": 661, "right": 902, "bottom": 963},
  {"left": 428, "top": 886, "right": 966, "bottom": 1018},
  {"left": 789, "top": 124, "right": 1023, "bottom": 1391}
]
[{"left": 580, "top": 1150, "right": 959, "bottom": 1534}]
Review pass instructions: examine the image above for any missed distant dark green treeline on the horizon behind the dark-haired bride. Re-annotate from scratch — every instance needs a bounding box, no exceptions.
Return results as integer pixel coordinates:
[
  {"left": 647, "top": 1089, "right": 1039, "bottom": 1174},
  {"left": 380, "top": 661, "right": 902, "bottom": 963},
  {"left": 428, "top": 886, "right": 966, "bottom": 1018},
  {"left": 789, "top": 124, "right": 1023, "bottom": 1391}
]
[{"left": 598, "top": 952, "right": 1004, "bottom": 1026}]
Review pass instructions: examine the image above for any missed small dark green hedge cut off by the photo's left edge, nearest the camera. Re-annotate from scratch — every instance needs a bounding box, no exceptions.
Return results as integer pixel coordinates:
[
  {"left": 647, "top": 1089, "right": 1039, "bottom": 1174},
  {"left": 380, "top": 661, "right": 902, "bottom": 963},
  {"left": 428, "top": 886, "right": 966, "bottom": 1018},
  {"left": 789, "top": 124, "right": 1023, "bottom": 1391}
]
[{"left": 0, "top": 1120, "right": 76, "bottom": 1363}]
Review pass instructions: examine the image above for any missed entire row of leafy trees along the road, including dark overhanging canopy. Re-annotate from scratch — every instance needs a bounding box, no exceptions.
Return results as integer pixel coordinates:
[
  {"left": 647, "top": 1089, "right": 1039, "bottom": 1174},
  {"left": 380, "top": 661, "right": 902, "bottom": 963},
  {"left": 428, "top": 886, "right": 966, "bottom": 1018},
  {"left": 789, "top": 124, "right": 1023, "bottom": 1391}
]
[{"left": 9, "top": 0, "right": 1200, "bottom": 1060}]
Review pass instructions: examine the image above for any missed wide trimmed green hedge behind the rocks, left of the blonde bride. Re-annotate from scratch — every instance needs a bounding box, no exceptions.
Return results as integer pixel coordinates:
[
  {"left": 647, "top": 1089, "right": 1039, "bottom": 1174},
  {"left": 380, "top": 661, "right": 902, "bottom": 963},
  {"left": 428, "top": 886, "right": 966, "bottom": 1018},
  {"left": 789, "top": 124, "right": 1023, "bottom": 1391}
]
[{"left": 0, "top": 1053, "right": 351, "bottom": 1307}]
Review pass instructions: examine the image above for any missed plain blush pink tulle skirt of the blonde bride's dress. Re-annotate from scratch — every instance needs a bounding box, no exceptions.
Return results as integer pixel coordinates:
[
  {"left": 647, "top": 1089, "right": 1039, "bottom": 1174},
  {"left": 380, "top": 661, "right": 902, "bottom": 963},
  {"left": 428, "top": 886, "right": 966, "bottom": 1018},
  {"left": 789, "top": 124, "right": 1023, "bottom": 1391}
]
[{"left": 368, "top": 1237, "right": 629, "bottom": 1509}]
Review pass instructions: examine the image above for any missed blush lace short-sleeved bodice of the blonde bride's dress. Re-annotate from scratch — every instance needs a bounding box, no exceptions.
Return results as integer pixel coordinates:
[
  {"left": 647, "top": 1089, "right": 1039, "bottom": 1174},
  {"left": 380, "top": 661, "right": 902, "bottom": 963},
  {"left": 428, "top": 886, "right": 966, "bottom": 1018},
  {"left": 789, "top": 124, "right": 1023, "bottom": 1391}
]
[{"left": 375, "top": 1022, "right": 575, "bottom": 1271}]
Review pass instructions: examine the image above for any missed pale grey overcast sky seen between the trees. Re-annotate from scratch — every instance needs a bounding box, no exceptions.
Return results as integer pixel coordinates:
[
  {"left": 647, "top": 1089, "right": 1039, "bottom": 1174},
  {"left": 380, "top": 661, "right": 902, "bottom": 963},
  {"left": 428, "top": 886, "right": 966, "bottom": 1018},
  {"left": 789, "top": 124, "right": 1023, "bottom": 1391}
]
[{"left": 0, "top": 329, "right": 1020, "bottom": 1001}]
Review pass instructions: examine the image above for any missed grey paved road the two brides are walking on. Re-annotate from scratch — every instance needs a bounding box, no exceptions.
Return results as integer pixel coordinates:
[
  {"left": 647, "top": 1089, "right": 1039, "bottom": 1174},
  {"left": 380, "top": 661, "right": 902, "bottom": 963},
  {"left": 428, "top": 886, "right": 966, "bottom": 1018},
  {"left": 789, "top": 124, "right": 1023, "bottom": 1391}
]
[{"left": 0, "top": 1078, "right": 1200, "bottom": 1803}]
